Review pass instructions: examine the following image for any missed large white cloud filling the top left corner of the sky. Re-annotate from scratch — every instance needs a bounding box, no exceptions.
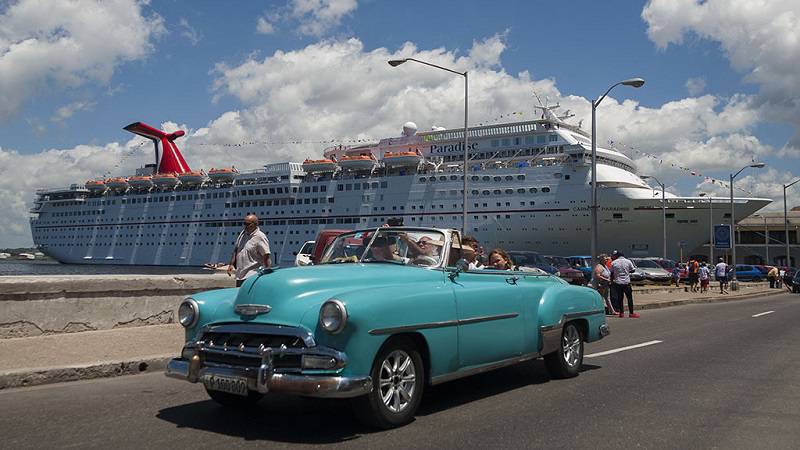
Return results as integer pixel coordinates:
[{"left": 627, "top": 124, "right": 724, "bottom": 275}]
[{"left": 0, "top": 0, "right": 163, "bottom": 120}]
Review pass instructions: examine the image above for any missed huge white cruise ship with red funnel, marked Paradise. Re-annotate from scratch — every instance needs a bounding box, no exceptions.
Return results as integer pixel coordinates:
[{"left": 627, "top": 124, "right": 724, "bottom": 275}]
[{"left": 30, "top": 106, "right": 770, "bottom": 266}]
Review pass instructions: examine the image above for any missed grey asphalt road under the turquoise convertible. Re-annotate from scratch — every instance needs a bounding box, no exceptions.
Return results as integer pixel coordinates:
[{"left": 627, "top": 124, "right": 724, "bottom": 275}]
[{"left": 0, "top": 294, "right": 800, "bottom": 449}]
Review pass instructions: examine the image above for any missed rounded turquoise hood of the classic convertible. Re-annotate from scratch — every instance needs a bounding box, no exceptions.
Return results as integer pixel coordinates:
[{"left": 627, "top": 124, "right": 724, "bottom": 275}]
[{"left": 214, "top": 263, "right": 443, "bottom": 326}]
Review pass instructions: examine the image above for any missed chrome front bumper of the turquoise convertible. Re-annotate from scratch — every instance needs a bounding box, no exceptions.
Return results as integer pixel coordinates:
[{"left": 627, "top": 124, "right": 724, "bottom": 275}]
[{"left": 166, "top": 357, "right": 372, "bottom": 398}]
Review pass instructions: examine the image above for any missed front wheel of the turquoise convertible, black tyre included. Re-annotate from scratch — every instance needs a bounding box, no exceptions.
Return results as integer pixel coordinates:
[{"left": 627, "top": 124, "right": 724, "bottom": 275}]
[{"left": 352, "top": 337, "right": 425, "bottom": 429}]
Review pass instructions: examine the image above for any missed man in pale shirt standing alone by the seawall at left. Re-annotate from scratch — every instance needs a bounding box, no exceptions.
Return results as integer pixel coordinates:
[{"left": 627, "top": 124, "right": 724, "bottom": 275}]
[{"left": 228, "top": 214, "right": 272, "bottom": 287}]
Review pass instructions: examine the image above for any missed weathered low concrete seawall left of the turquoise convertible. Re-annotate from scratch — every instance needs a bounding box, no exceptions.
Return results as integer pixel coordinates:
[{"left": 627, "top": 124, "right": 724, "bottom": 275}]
[{"left": 0, "top": 273, "right": 234, "bottom": 339}]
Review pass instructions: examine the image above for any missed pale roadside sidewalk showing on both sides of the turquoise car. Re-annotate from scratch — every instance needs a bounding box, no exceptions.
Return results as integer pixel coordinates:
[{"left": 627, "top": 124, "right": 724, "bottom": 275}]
[{"left": 0, "top": 283, "right": 786, "bottom": 390}]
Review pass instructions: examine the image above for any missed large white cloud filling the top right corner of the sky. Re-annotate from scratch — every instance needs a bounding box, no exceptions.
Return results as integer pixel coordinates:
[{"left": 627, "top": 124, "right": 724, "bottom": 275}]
[{"left": 642, "top": 0, "right": 800, "bottom": 147}]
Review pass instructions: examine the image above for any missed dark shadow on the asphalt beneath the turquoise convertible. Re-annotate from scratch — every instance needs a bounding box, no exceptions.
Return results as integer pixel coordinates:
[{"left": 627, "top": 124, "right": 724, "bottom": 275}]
[{"left": 156, "top": 359, "right": 599, "bottom": 444}]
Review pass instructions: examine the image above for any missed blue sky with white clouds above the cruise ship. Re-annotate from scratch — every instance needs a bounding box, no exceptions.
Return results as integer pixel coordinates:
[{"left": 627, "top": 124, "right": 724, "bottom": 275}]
[{"left": 0, "top": 0, "right": 800, "bottom": 247}]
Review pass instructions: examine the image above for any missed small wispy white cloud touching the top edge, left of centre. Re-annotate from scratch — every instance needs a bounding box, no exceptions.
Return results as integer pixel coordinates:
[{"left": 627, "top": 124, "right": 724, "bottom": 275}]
[{"left": 256, "top": 0, "right": 358, "bottom": 37}]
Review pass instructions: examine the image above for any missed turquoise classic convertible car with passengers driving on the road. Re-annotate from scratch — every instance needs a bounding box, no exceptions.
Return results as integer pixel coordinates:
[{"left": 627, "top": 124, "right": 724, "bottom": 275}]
[{"left": 166, "top": 227, "right": 608, "bottom": 428}]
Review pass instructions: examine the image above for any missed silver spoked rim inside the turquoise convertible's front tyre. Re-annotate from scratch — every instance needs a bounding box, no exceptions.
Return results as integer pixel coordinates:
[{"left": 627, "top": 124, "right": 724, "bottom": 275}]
[{"left": 378, "top": 350, "right": 416, "bottom": 413}]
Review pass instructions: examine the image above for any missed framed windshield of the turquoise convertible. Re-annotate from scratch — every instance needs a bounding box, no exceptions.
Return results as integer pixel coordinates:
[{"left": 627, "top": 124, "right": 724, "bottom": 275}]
[{"left": 320, "top": 228, "right": 445, "bottom": 266}]
